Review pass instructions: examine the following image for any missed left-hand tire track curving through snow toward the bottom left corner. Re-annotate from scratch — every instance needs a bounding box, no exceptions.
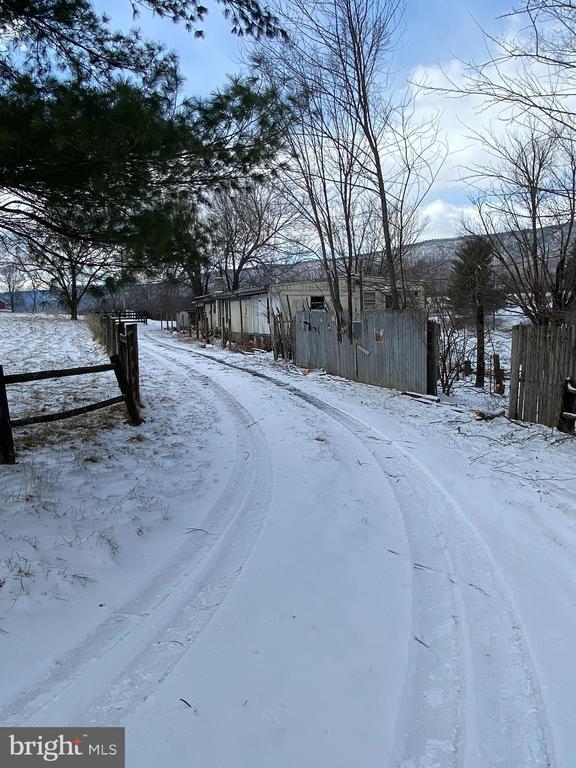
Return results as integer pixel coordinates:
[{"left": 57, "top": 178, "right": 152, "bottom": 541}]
[{"left": 0, "top": 348, "right": 272, "bottom": 725}]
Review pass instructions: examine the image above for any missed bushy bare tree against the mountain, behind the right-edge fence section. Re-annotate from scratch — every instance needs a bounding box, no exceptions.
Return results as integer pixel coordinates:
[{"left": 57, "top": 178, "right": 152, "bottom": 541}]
[{"left": 468, "top": 122, "right": 576, "bottom": 325}]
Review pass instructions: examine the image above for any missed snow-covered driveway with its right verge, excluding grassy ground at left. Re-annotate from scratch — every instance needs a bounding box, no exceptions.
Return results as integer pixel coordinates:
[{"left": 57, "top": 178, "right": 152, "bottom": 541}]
[{"left": 0, "top": 316, "right": 576, "bottom": 768}]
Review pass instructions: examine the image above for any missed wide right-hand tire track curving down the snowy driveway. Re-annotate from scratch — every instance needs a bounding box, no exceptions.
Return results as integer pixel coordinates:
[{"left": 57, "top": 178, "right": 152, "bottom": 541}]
[{"left": 154, "top": 340, "right": 555, "bottom": 768}]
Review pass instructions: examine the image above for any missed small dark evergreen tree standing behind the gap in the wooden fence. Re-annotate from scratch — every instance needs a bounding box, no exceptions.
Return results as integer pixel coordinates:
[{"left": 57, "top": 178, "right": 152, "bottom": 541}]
[{"left": 449, "top": 236, "right": 505, "bottom": 387}]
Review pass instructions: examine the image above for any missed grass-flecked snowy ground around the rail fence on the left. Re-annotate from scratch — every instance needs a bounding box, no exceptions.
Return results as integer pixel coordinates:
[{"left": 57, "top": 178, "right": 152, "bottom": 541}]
[{"left": 0, "top": 314, "right": 213, "bottom": 642}]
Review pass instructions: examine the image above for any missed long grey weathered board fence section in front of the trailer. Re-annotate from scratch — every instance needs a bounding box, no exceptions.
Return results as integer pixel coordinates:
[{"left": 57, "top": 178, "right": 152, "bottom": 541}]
[{"left": 292, "top": 310, "right": 437, "bottom": 394}]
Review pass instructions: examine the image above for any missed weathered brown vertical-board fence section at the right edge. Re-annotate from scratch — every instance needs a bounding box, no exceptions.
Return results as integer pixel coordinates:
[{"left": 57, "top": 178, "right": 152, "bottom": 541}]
[{"left": 509, "top": 325, "right": 576, "bottom": 429}]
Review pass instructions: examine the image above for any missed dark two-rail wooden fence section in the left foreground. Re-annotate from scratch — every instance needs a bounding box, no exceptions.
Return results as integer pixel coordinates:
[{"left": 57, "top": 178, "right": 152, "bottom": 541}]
[{"left": 0, "top": 354, "right": 142, "bottom": 464}]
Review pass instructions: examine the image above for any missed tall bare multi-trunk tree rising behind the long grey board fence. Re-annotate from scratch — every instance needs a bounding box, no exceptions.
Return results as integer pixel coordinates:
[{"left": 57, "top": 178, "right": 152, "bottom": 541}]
[{"left": 257, "top": 0, "right": 445, "bottom": 316}]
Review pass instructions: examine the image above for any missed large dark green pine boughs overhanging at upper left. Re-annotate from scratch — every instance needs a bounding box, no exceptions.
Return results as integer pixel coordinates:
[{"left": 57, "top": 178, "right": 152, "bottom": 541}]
[{"left": 0, "top": 0, "right": 284, "bottom": 270}]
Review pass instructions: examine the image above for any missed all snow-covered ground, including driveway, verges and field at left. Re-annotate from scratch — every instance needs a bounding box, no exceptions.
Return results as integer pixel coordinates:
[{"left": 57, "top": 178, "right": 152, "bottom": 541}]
[{"left": 0, "top": 316, "right": 576, "bottom": 768}]
